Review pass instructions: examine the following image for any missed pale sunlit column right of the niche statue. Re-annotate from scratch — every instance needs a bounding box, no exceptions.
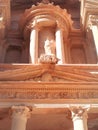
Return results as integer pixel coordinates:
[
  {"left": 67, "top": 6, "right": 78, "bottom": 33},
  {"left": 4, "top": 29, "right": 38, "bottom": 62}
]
[{"left": 55, "top": 28, "right": 65, "bottom": 64}]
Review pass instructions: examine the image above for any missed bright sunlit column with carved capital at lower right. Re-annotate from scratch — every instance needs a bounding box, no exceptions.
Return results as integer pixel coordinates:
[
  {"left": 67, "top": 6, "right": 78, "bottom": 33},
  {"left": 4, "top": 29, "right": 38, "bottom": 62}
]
[{"left": 70, "top": 107, "right": 88, "bottom": 130}]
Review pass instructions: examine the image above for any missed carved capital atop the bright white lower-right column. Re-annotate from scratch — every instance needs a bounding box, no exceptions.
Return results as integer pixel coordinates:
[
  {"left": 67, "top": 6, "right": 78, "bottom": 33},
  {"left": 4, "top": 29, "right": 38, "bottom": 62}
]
[{"left": 70, "top": 106, "right": 88, "bottom": 121}]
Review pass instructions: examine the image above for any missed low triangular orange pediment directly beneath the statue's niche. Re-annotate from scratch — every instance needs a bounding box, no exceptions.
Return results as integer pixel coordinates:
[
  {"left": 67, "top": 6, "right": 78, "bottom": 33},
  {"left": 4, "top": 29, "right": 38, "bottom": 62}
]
[{"left": 0, "top": 64, "right": 98, "bottom": 82}]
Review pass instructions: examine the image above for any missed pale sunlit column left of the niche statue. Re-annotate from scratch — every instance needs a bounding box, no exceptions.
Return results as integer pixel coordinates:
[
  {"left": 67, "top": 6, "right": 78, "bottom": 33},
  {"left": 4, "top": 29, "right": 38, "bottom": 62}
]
[{"left": 30, "top": 27, "right": 38, "bottom": 64}]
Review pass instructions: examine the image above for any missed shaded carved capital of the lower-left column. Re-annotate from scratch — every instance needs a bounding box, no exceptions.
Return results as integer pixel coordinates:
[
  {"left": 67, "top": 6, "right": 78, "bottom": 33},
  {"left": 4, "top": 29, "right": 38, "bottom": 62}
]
[{"left": 11, "top": 106, "right": 30, "bottom": 118}]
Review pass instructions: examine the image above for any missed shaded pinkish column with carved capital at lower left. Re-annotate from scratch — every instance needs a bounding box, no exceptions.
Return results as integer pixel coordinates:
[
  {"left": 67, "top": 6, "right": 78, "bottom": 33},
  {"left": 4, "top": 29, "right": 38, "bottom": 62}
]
[{"left": 11, "top": 106, "right": 29, "bottom": 130}]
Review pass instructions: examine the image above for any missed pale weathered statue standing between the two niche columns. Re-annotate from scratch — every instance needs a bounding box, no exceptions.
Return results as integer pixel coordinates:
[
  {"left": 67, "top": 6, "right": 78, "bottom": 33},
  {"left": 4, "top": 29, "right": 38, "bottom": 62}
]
[{"left": 44, "top": 39, "right": 56, "bottom": 55}]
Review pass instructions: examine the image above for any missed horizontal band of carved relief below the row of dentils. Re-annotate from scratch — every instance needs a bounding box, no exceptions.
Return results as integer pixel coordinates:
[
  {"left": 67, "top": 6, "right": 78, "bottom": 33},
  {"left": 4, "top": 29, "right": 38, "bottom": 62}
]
[{"left": 0, "top": 88, "right": 98, "bottom": 100}]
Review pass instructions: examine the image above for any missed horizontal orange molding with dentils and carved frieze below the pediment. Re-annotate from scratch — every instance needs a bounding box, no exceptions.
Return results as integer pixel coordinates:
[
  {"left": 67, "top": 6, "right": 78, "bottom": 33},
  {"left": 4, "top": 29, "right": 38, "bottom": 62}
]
[{"left": 0, "top": 82, "right": 98, "bottom": 100}]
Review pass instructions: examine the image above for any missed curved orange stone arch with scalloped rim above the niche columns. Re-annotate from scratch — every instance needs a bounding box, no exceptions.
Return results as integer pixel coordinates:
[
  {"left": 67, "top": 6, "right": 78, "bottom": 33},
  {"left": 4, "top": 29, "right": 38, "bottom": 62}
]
[{"left": 20, "top": 3, "right": 73, "bottom": 40}]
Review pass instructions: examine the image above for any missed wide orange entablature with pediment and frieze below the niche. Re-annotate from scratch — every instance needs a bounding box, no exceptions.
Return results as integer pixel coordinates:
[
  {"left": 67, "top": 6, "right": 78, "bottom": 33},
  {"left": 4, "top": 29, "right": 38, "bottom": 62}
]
[{"left": 0, "top": 64, "right": 98, "bottom": 100}]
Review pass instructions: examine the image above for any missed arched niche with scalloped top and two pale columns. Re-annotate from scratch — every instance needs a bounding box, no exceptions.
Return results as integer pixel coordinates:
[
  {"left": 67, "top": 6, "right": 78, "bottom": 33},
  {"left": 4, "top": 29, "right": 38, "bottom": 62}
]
[{"left": 20, "top": 3, "right": 72, "bottom": 64}]
